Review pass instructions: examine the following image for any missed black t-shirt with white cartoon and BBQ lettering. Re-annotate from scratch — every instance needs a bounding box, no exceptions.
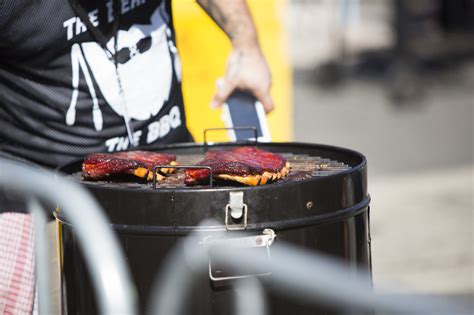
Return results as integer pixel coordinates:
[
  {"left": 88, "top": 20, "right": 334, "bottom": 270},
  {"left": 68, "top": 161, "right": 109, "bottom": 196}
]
[{"left": 0, "top": 0, "right": 191, "bottom": 166}]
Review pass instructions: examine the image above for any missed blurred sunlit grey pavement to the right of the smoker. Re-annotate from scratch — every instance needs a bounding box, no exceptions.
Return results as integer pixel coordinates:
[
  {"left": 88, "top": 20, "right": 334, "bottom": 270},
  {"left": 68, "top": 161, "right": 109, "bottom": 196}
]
[{"left": 294, "top": 64, "right": 474, "bottom": 297}]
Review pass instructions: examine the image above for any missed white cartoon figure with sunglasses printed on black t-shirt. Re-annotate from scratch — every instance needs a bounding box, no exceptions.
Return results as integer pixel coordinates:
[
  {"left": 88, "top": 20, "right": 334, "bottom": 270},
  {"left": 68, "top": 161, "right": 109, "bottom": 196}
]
[{"left": 66, "top": 4, "right": 181, "bottom": 131}]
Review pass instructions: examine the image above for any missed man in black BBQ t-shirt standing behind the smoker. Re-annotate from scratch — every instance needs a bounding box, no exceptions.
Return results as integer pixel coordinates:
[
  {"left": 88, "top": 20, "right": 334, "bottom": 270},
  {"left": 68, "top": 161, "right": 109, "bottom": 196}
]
[{"left": 0, "top": 0, "right": 273, "bottom": 313}]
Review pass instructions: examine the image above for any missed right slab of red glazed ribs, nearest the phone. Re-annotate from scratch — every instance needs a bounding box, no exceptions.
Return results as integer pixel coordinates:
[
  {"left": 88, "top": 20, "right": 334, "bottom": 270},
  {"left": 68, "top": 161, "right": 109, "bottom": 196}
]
[{"left": 184, "top": 147, "right": 290, "bottom": 186}]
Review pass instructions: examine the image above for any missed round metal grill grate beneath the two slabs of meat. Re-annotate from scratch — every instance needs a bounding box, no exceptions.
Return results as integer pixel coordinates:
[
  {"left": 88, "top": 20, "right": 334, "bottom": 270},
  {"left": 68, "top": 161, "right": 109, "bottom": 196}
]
[{"left": 71, "top": 153, "right": 351, "bottom": 189}]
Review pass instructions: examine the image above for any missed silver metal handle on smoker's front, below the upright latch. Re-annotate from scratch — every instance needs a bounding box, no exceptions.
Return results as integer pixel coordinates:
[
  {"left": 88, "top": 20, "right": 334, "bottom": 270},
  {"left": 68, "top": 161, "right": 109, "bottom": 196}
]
[{"left": 205, "top": 229, "right": 276, "bottom": 282}]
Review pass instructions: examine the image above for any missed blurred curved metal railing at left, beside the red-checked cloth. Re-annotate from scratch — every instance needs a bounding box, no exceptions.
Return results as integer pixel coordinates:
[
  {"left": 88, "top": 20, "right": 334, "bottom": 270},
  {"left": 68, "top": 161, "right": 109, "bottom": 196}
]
[{"left": 0, "top": 159, "right": 137, "bottom": 314}]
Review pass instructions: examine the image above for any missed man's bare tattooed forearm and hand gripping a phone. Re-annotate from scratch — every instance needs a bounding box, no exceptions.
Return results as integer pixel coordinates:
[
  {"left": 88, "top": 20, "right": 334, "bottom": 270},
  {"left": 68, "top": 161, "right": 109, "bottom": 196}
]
[{"left": 197, "top": 0, "right": 273, "bottom": 113}]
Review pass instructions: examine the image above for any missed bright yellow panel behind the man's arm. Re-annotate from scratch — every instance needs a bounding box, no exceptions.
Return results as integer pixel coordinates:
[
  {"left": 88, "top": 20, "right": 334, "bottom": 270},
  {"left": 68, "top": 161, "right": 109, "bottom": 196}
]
[{"left": 172, "top": 0, "right": 293, "bottom": 142}]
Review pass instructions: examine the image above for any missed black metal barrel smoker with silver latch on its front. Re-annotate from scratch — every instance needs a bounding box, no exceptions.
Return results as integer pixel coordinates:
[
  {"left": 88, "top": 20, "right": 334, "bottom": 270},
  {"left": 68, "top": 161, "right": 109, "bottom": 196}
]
[{"left": 57, "top": 143, "right": 371, "bottom": 314}]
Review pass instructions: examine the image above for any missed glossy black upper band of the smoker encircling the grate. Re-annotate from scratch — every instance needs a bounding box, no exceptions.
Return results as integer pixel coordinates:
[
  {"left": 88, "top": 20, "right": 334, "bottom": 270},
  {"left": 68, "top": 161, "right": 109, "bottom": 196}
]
[{"left": 58, "top": 142, "right": 369, "bottom": 228}]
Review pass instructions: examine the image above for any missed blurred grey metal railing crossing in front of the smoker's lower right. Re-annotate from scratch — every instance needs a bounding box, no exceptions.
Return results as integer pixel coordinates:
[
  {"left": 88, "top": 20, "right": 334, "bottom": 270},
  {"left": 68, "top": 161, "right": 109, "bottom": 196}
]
[{"left": 148, "top": 222, "right": 468, "bottom": 315}]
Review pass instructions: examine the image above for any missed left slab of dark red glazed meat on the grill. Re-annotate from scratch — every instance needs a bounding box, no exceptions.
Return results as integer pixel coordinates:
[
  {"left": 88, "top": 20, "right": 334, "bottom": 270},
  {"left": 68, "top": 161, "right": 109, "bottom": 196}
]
[{"left": 82, "top": 151, "right": 176, "bottom": 180}]
